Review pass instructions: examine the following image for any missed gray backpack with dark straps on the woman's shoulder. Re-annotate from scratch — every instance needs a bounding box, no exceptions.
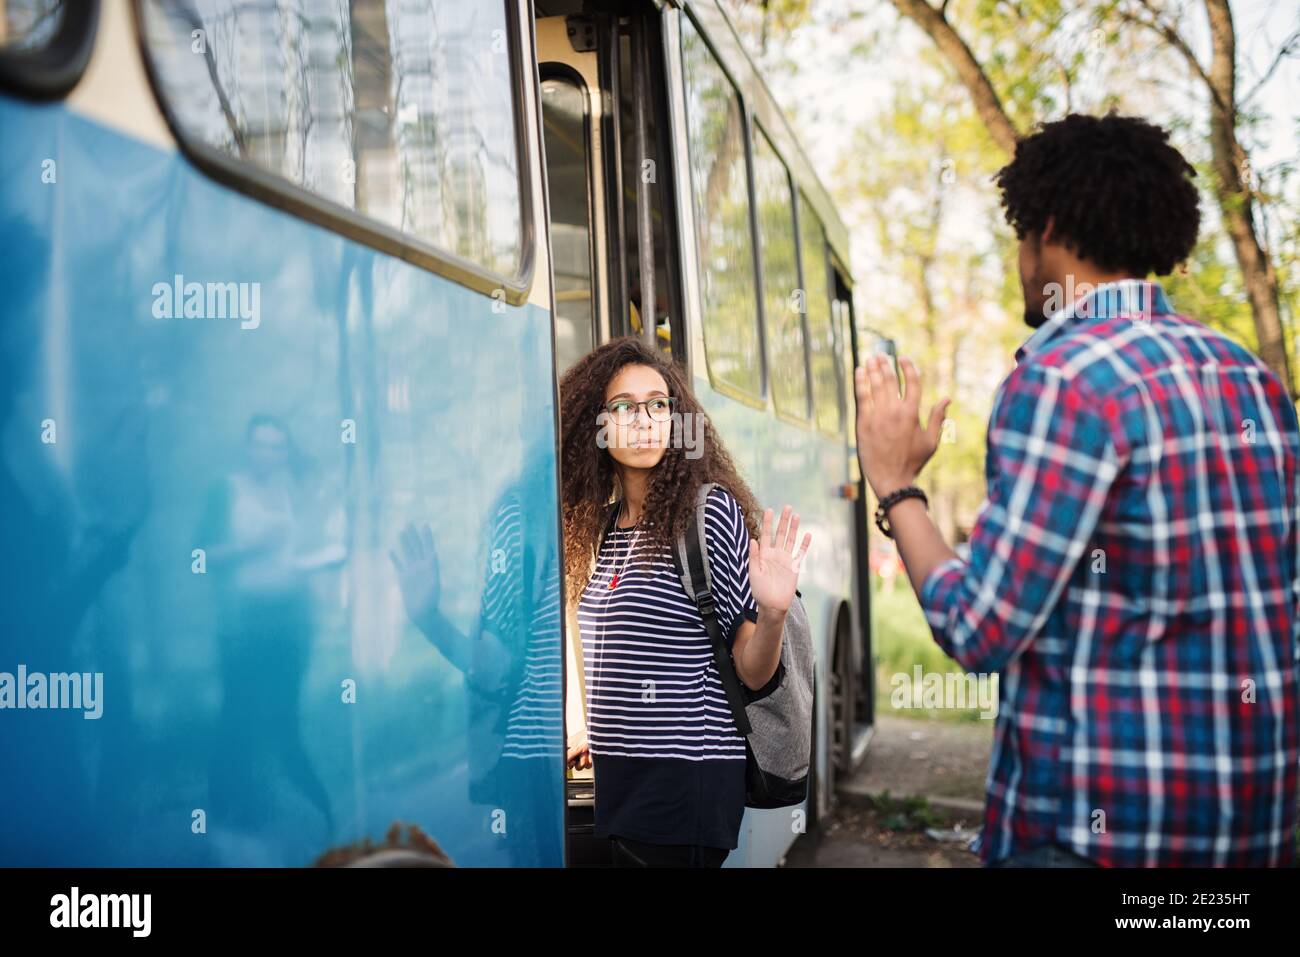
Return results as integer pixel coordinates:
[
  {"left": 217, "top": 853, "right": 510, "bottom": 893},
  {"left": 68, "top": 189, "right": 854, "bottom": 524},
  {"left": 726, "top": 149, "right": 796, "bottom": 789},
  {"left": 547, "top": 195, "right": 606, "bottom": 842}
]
[{"left": 672, "top": 482, "right": 814, "bottom": 807}]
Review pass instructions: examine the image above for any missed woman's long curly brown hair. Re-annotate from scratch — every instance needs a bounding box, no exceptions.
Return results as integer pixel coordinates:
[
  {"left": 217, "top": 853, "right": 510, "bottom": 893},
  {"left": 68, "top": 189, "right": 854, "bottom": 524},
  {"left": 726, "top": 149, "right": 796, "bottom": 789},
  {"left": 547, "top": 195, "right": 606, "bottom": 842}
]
[{"left": 560, "top": 335, "right": 762, "bottom": 602}]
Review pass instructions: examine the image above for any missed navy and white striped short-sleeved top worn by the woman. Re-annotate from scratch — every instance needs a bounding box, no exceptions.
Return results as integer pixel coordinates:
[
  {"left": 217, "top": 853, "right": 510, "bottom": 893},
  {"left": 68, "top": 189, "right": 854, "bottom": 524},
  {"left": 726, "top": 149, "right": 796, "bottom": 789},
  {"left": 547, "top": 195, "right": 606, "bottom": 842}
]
[{"left": 577, "top": 488, "right": 758, "bottom": 848}]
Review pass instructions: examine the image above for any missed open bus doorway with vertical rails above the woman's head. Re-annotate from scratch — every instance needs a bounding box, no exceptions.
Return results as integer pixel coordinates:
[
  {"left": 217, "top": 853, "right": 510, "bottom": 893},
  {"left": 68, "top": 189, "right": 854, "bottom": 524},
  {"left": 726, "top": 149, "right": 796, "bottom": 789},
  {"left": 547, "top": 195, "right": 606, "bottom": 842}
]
[{"left": 537, "top": 0, "right": 685, "bottom": 374}]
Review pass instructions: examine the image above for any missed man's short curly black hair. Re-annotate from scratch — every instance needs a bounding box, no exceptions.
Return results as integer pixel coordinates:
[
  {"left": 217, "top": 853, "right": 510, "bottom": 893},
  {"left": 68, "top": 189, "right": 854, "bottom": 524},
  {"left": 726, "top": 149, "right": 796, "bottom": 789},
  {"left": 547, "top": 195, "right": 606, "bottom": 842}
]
[{"left": 996, "top": 112, "right": 1201, "bottom": 277}]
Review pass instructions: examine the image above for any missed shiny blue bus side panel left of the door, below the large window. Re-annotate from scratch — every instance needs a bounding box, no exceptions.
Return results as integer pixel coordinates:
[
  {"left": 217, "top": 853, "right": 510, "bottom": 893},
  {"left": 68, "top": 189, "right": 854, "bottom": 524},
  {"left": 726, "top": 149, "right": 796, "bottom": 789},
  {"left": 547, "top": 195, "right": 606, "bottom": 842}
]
[{"left": 0, "top": 99, "right": 564, "bottom": 866}]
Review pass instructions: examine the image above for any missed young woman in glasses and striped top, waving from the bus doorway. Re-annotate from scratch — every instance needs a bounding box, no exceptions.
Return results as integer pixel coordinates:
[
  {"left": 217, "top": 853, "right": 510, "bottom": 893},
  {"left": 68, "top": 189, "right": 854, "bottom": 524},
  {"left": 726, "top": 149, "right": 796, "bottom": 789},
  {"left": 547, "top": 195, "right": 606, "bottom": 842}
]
[{"left": 560, "top": 337, "right": 811, "bottom": 867}]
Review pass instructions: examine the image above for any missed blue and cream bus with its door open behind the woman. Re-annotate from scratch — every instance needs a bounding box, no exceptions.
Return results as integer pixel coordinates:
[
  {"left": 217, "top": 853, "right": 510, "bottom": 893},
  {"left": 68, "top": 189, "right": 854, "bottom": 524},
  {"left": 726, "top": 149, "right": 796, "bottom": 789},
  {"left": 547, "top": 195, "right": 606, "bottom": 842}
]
[{"left": 0, "top": 0, "right": 872, "bottom": 866}]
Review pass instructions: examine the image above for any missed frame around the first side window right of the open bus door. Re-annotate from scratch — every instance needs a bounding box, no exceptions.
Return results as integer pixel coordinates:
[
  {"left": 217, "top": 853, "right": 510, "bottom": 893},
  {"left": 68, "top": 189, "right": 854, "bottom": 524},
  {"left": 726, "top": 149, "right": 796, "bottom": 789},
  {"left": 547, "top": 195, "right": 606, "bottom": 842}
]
[{"left": 677, "top": 9, "right": 771, "bottom": 410}]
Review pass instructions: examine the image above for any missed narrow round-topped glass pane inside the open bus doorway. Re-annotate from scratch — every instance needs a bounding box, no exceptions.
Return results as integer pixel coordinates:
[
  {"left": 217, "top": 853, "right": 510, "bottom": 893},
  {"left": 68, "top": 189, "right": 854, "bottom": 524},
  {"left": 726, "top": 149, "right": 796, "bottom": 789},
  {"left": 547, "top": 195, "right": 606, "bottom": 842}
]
[{"left": 542, "top": 78, "right": 595, "bottom": 374}]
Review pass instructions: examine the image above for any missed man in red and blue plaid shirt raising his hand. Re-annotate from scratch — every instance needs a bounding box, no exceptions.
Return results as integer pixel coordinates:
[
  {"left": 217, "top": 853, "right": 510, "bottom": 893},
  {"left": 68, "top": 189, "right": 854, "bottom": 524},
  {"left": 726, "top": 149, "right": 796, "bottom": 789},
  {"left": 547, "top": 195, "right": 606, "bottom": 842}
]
[{"left": 857, "top": 113, "right": 1300, "bottom": 867}]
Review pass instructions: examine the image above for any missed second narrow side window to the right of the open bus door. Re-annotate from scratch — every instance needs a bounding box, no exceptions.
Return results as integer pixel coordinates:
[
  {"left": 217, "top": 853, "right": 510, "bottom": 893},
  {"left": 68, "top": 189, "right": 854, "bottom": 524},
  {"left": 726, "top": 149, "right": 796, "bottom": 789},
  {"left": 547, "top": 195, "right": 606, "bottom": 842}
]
[{"left": 754, "top": 129, "right": 809, "bottom": 420}]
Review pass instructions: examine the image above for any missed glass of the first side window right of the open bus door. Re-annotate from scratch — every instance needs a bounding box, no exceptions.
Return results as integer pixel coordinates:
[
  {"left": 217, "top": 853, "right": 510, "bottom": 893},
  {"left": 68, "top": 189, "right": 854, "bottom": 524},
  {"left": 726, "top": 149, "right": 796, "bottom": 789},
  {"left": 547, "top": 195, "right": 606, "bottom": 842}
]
[{"left": 681, "top": 17, "right": 763, "bottom": 395}]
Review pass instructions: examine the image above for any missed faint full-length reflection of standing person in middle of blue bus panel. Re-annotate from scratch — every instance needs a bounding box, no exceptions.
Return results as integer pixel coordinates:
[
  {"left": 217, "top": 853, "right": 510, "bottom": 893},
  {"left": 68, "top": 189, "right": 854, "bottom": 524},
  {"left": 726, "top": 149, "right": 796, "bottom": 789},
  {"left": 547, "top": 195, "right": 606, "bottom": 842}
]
[{"left": 198, "top": 415, "right": 345, "bottom": 833}]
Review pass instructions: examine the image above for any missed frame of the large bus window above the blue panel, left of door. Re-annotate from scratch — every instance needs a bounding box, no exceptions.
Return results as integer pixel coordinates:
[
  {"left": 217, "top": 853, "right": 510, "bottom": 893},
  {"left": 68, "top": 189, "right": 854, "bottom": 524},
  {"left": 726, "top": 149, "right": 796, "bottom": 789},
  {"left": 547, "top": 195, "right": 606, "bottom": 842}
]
[{"left": 131, "top": 0, "right": 545, "bottom": 306}]
